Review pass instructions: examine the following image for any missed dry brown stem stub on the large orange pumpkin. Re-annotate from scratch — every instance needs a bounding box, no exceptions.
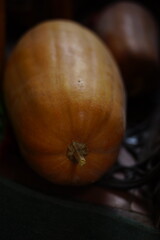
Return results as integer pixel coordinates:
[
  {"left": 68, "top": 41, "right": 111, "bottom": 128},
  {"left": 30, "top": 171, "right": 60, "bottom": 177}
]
[{"left": 67, "top": 142, "right": 88, "bottom": 166}]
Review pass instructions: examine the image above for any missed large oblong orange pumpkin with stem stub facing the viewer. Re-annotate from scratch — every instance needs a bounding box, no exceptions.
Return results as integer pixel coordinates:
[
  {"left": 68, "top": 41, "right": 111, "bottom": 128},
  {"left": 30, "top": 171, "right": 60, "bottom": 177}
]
[{"left": 3, "top": 20, "right": 125, "bottom": 185}]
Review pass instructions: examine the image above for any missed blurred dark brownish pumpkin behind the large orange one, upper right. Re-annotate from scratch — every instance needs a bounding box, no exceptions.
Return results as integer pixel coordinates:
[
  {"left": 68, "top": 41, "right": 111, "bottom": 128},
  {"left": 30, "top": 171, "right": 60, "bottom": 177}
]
[{"left": 90, "top": 2, "right": 159, "bottom": 97}]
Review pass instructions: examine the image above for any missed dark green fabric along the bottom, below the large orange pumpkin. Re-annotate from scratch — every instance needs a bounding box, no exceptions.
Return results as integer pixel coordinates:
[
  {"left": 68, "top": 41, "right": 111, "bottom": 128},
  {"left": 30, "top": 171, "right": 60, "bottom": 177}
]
[{"left": 0, "top": 176, "right": 160, "bottom": 240}]
